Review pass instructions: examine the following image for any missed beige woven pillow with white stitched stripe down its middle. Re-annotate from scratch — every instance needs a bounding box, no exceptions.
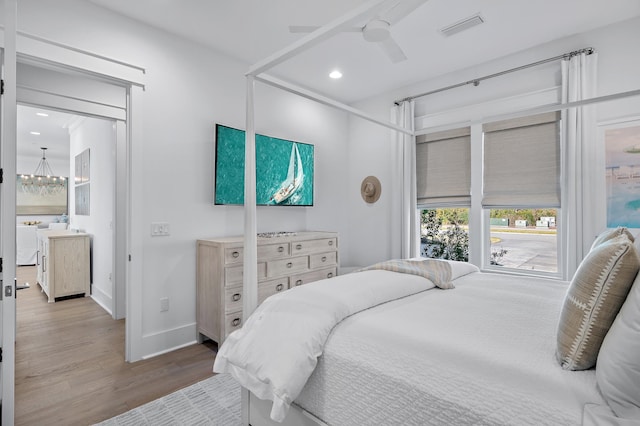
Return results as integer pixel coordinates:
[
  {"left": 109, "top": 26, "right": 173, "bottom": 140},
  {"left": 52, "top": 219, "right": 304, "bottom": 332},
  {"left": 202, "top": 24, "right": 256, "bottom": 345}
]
[{"left": 556, "top": 234, "right": 640, "bottom": 370}]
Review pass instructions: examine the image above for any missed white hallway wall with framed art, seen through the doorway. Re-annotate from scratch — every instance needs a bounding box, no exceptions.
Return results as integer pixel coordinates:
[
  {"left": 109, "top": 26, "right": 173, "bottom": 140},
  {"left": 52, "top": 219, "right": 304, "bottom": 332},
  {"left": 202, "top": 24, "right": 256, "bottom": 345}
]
[{"left": 69, "top": 117, "right": 116, "bottom": 314}]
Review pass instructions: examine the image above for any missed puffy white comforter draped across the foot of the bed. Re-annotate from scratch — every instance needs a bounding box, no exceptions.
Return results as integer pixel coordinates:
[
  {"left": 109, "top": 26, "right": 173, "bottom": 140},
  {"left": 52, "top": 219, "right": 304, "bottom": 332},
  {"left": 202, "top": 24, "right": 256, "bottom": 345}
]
[{"left": 213, "top": 262, "right": 478, "bottom": 421}]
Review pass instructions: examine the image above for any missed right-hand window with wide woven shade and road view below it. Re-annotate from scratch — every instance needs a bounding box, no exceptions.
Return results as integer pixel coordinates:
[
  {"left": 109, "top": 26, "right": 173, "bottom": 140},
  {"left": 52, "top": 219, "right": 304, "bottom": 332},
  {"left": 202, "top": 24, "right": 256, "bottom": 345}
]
[{"left": 482, "top": 113, "right": 560, "bottom": 273}]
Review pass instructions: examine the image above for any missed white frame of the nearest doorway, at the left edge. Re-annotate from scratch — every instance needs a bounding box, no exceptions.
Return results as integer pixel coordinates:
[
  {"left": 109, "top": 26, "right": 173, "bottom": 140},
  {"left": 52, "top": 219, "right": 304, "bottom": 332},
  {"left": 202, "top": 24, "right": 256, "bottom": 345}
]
[{"left": 0, "top": 10, "right": 146, "bottom": 425}]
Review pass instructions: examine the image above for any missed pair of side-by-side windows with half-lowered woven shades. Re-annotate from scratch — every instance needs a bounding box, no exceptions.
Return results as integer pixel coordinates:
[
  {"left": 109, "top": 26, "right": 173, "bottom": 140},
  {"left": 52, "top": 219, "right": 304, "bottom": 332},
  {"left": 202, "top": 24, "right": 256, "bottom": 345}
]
[{"left": 416, "top": 112, "right": 561, "bottom": 276}]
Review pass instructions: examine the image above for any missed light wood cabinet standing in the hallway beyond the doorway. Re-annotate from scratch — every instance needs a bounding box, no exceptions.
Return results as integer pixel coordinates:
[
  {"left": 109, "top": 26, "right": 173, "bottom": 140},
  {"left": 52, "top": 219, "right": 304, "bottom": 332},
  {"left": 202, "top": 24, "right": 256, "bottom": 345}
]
[{"left": 36, "top": 230, "right": 91, "bottom": 303}]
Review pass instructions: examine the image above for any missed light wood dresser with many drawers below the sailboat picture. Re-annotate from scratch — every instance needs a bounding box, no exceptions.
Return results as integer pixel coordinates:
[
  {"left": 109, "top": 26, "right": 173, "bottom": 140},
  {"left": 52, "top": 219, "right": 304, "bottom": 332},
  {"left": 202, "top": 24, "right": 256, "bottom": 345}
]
[{"left": 196, "top": 231, "right": 339, "bottom": 345}]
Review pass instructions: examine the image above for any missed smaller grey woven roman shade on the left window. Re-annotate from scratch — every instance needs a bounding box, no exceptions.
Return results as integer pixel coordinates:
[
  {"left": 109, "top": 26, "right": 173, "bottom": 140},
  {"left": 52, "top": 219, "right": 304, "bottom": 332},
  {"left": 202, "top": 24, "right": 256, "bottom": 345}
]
[{"left": 416, "top": 127, "right": 471, "bottom": 207}]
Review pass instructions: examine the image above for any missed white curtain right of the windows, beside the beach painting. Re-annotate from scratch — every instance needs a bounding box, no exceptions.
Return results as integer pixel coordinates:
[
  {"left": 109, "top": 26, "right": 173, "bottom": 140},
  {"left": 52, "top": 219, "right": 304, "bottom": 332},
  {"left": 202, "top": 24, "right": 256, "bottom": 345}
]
[{"left": 561, "top": 53, "right": 604, "bottom": 279}]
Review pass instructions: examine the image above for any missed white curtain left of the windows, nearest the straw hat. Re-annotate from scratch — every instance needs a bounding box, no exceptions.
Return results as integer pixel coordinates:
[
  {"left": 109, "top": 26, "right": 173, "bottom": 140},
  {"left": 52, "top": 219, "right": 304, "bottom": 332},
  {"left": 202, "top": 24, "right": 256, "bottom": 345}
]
[{"left": 392, "top": 101, "right": 420, "bottom": 259}]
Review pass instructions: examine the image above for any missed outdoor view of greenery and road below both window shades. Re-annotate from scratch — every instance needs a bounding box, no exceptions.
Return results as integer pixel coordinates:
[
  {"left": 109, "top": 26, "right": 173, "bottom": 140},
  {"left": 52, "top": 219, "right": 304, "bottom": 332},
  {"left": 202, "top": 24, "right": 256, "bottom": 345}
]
[{"left": 420, "top": 208, "right": 558, "bottom": 273}]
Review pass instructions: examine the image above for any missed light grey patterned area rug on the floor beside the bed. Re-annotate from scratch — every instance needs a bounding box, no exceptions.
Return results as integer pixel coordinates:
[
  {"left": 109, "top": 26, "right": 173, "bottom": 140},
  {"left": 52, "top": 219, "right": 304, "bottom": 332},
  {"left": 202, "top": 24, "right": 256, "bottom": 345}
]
[{"left": 98, "top": 374, "right": 242, "bottom": 426}]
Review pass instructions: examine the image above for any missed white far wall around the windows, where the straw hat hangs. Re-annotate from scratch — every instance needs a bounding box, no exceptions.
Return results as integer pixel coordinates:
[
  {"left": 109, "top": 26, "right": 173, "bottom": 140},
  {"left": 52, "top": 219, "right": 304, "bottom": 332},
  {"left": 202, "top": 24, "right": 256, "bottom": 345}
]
[{"left": 346, "top": 19, "right": 640, "bottom": 265}]
